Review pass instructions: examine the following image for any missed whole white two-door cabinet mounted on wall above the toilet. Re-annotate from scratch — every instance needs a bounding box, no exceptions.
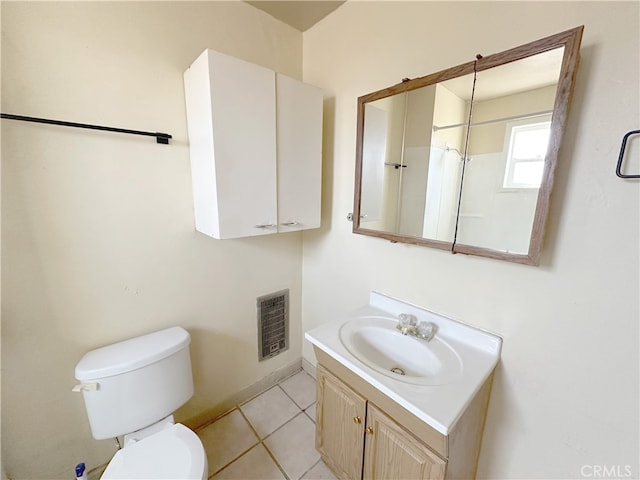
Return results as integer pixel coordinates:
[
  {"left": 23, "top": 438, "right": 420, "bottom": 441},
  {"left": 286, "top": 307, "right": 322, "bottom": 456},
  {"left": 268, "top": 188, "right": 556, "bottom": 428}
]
[{"left": 184, "top": 50, "right": 322, "bottom": 239}]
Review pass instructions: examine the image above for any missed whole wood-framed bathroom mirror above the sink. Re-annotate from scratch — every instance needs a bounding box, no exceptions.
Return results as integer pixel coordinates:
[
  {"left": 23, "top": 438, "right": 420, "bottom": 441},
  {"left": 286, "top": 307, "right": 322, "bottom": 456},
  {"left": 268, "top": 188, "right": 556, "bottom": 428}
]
[{"left": 352, "top": 27, "right": 583, "bottom": 265}]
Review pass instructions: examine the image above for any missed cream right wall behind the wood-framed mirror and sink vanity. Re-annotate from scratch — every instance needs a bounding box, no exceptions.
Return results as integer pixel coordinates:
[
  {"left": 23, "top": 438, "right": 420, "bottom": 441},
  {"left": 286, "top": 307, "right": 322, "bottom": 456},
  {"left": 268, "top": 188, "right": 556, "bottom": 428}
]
[{"left": 302, "top": 1, "right": 640, "bottom": 479}]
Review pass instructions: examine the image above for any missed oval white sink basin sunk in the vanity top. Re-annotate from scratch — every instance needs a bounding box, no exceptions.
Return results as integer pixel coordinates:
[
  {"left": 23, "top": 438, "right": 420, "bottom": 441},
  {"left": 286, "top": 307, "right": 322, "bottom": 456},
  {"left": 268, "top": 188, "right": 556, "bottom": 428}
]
[{"left": 340, "top": 316, "right": 462, "bottom": 386}]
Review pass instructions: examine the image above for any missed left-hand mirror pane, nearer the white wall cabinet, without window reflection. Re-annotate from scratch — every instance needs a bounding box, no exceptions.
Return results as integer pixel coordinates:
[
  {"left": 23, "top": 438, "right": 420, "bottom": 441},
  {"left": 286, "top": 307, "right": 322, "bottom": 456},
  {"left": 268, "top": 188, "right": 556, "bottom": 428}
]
[{"left": 360, "top": 75, "right": 473, "bottom": 244}]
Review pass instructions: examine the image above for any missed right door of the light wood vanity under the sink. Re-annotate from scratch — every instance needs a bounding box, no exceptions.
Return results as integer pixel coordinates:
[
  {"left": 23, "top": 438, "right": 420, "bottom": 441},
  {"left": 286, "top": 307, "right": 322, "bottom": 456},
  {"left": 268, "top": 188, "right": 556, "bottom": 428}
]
[{"left": 364, "top": 404, "right": 447, "bottom": 480}]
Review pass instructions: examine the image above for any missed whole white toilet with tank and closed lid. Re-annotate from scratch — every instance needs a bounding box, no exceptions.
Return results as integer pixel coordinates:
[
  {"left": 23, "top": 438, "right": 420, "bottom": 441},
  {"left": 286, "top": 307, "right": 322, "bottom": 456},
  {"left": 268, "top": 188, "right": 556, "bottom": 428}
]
[{"left": 74, "top": 327, "right": 208, "bottom": 480}]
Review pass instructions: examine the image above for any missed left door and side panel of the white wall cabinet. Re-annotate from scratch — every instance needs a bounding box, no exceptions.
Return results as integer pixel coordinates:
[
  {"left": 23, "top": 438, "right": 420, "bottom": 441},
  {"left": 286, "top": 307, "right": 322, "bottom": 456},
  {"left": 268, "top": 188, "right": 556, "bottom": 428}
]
[{"left": 185, "top": 50, "right": 277, "bottom": 238}]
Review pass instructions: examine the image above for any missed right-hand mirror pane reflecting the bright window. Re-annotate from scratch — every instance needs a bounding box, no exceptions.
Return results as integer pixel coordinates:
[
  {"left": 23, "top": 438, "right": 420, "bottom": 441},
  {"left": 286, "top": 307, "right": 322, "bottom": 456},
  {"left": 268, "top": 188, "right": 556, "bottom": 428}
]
[{"left": 456, "top": 47, "right": 564, "bottom": 255}]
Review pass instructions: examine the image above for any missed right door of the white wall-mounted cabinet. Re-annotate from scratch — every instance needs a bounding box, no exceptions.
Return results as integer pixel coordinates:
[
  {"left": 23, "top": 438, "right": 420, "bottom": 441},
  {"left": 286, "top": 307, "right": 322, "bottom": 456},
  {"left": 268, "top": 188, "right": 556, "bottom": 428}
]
[{"left": 276, "top": 74, "right": 322, "bottom": 232}]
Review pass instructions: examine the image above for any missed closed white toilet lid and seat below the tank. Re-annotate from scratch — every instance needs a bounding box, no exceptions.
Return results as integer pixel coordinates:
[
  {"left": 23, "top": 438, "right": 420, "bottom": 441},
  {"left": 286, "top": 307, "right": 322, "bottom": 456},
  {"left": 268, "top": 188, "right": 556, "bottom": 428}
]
[{"left": 101, "top": 423, "right": 208, "bottom": 480}]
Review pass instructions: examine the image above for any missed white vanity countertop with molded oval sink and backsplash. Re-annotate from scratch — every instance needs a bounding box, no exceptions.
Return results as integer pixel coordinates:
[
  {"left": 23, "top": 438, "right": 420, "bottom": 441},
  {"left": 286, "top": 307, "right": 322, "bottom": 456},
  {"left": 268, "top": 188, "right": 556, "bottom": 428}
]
[{"left": 305, "top": 292, "right": 502, "bottom": 435}]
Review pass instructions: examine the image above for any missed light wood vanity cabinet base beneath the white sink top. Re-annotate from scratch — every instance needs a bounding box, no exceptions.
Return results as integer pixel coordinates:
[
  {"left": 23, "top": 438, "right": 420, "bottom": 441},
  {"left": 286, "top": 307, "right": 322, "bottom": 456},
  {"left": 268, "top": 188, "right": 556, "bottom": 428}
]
[{"left": 314, "top": 354, "right": 492, "bottom": 480}]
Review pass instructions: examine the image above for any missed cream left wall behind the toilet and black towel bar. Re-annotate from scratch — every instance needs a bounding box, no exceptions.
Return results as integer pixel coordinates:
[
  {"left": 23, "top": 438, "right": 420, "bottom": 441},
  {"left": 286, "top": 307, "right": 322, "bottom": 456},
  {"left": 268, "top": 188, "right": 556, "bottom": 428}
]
[{"left": 1, "top": 2, "right": 302, "bottom": 479}]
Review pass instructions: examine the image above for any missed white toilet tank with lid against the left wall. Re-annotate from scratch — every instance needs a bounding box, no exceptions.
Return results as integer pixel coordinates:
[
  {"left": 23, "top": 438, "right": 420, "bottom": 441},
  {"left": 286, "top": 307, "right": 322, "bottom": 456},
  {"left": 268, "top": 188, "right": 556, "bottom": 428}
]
[{"left": 75, "top": 327, "right": 193, "bottom": 440}]
